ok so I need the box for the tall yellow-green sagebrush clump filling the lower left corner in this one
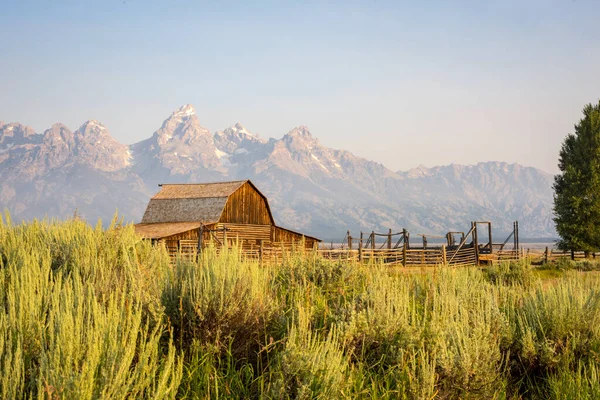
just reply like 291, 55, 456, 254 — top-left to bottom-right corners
0, 212, 182, 399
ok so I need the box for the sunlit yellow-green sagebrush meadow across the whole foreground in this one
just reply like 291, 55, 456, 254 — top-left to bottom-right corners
0, 215, 600, 399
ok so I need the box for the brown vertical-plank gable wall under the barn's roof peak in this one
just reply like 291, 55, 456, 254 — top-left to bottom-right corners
219, 182, 274, 225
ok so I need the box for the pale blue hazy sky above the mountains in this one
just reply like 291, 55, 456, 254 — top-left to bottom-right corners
0, 0, 600, 173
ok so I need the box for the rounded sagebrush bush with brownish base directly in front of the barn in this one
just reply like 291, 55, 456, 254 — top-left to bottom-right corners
162, 245, 279, 358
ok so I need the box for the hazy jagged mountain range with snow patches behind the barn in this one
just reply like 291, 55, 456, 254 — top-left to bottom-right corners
0, 105, 555, 241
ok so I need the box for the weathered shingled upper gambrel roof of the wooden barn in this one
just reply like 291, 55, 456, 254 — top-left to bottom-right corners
142, 180, 273, 224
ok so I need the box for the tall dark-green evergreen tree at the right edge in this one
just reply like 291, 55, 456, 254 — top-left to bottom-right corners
554, 101, 600, 252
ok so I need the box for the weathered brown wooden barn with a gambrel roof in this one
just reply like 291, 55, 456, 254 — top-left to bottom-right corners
135, 180, 320, 254
